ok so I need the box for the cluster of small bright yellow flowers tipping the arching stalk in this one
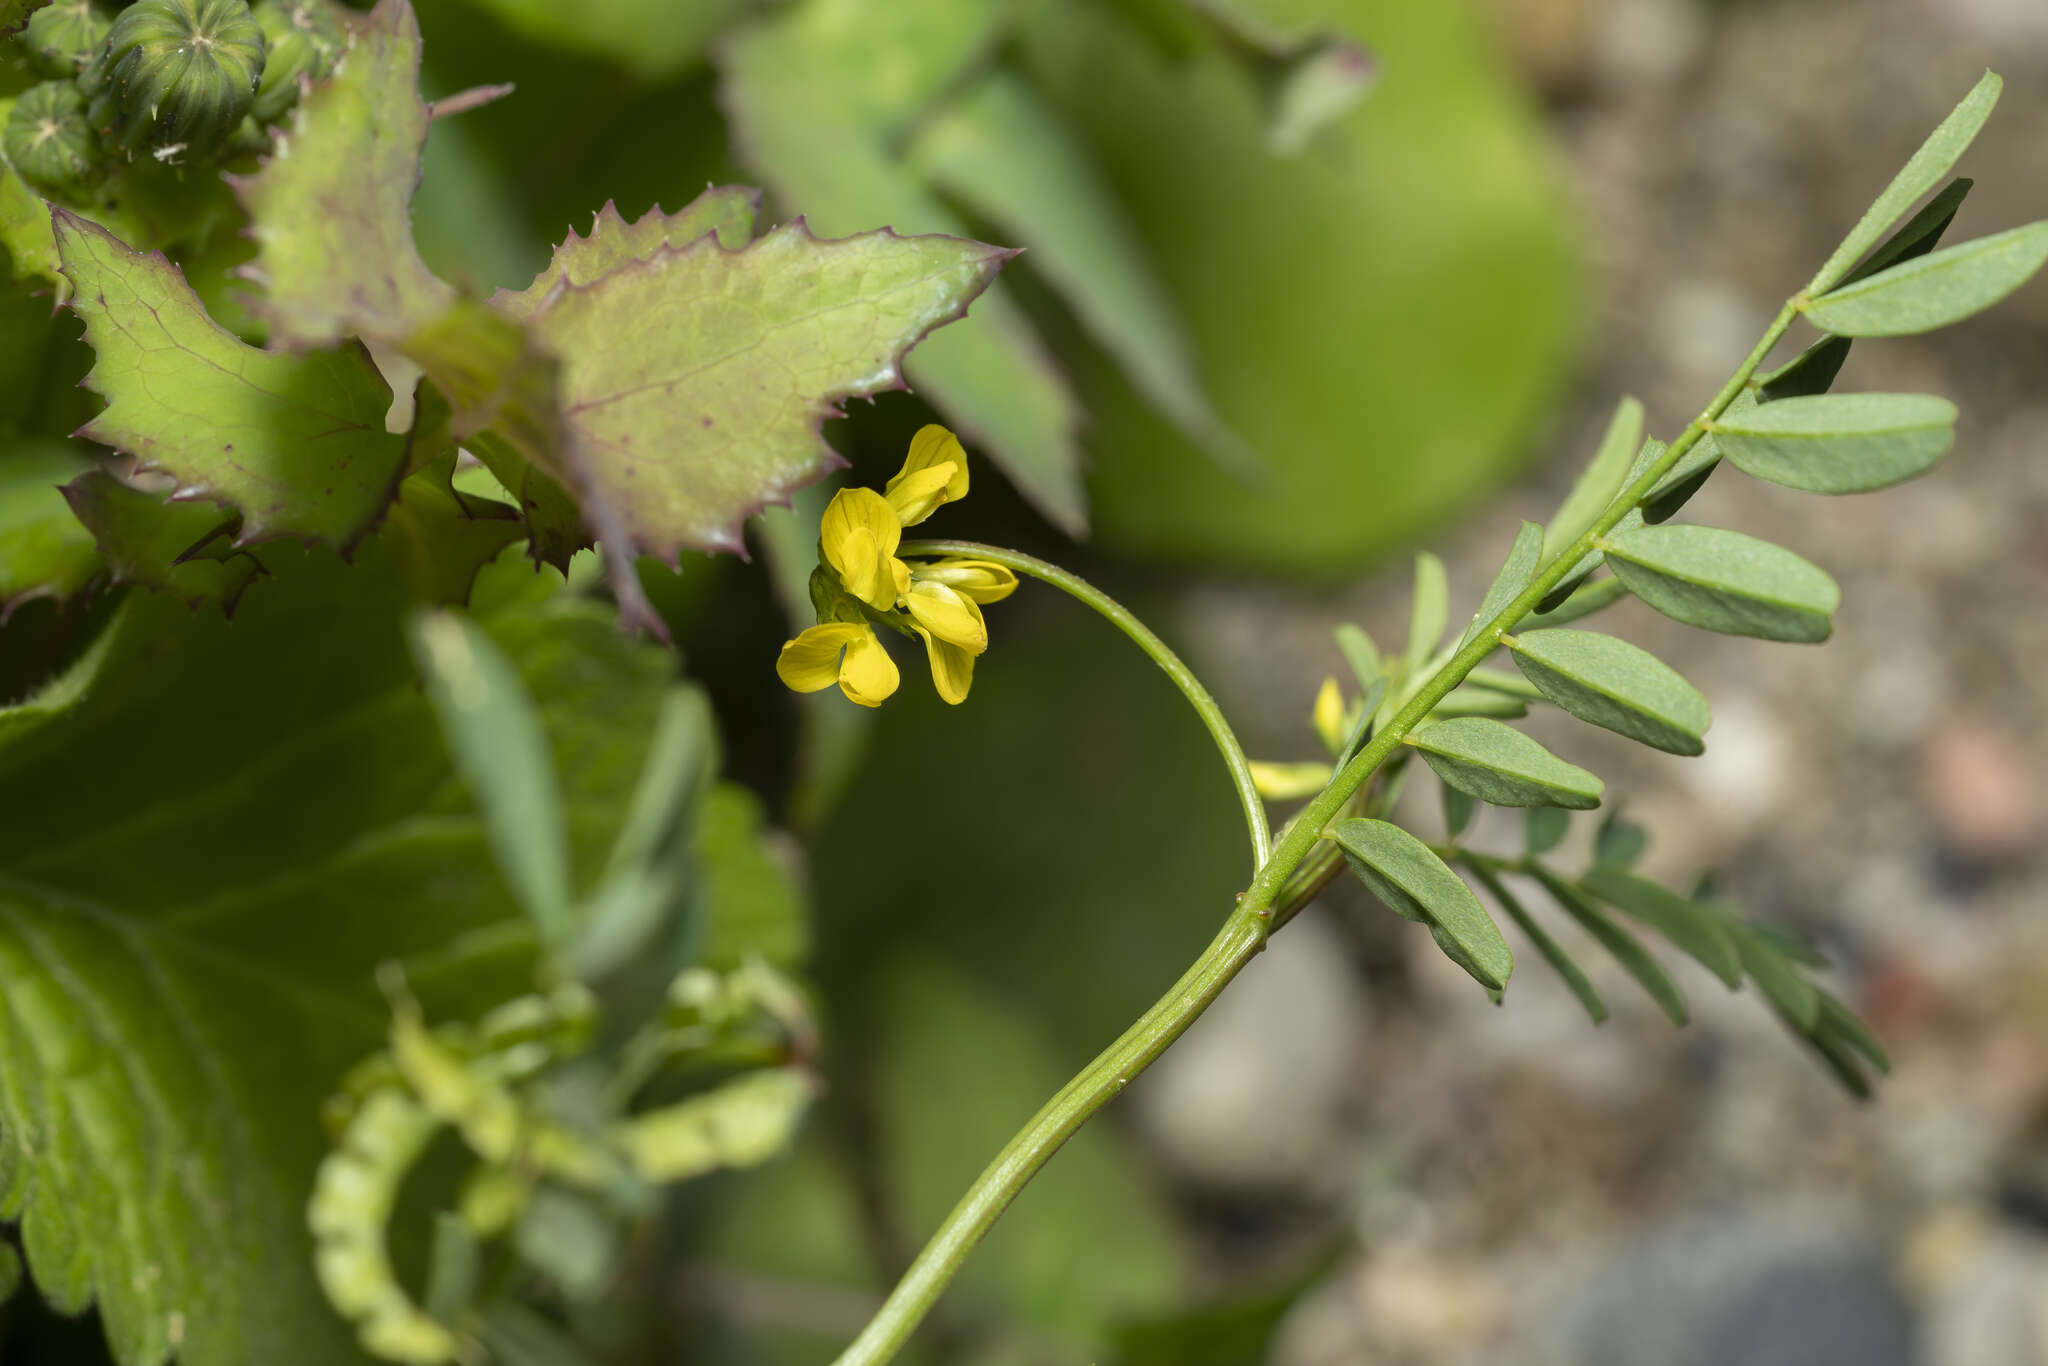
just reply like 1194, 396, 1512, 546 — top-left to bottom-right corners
774, 424, 1018, 707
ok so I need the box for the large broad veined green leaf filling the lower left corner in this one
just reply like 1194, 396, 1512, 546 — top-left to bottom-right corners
0, 543, 672, 1366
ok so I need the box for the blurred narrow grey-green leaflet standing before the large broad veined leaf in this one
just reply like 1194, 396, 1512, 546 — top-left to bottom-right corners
410, 612, 569, 948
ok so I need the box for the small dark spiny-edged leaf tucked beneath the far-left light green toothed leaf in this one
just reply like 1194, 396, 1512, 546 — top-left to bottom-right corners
63, 469, 264, 616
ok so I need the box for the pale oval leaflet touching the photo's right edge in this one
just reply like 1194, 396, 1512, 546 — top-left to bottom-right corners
1806, 221, 2048, 336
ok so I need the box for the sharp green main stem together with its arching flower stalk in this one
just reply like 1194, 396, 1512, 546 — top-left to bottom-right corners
834, 295, 1802, 1366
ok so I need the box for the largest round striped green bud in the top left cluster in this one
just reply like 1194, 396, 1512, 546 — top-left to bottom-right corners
80, 0, 264, 162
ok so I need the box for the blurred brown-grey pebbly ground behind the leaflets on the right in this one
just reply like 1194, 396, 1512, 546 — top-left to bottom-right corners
1137, 0, 2048, 1366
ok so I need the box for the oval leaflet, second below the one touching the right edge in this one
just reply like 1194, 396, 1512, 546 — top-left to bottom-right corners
1602, 526, 1841, 641
